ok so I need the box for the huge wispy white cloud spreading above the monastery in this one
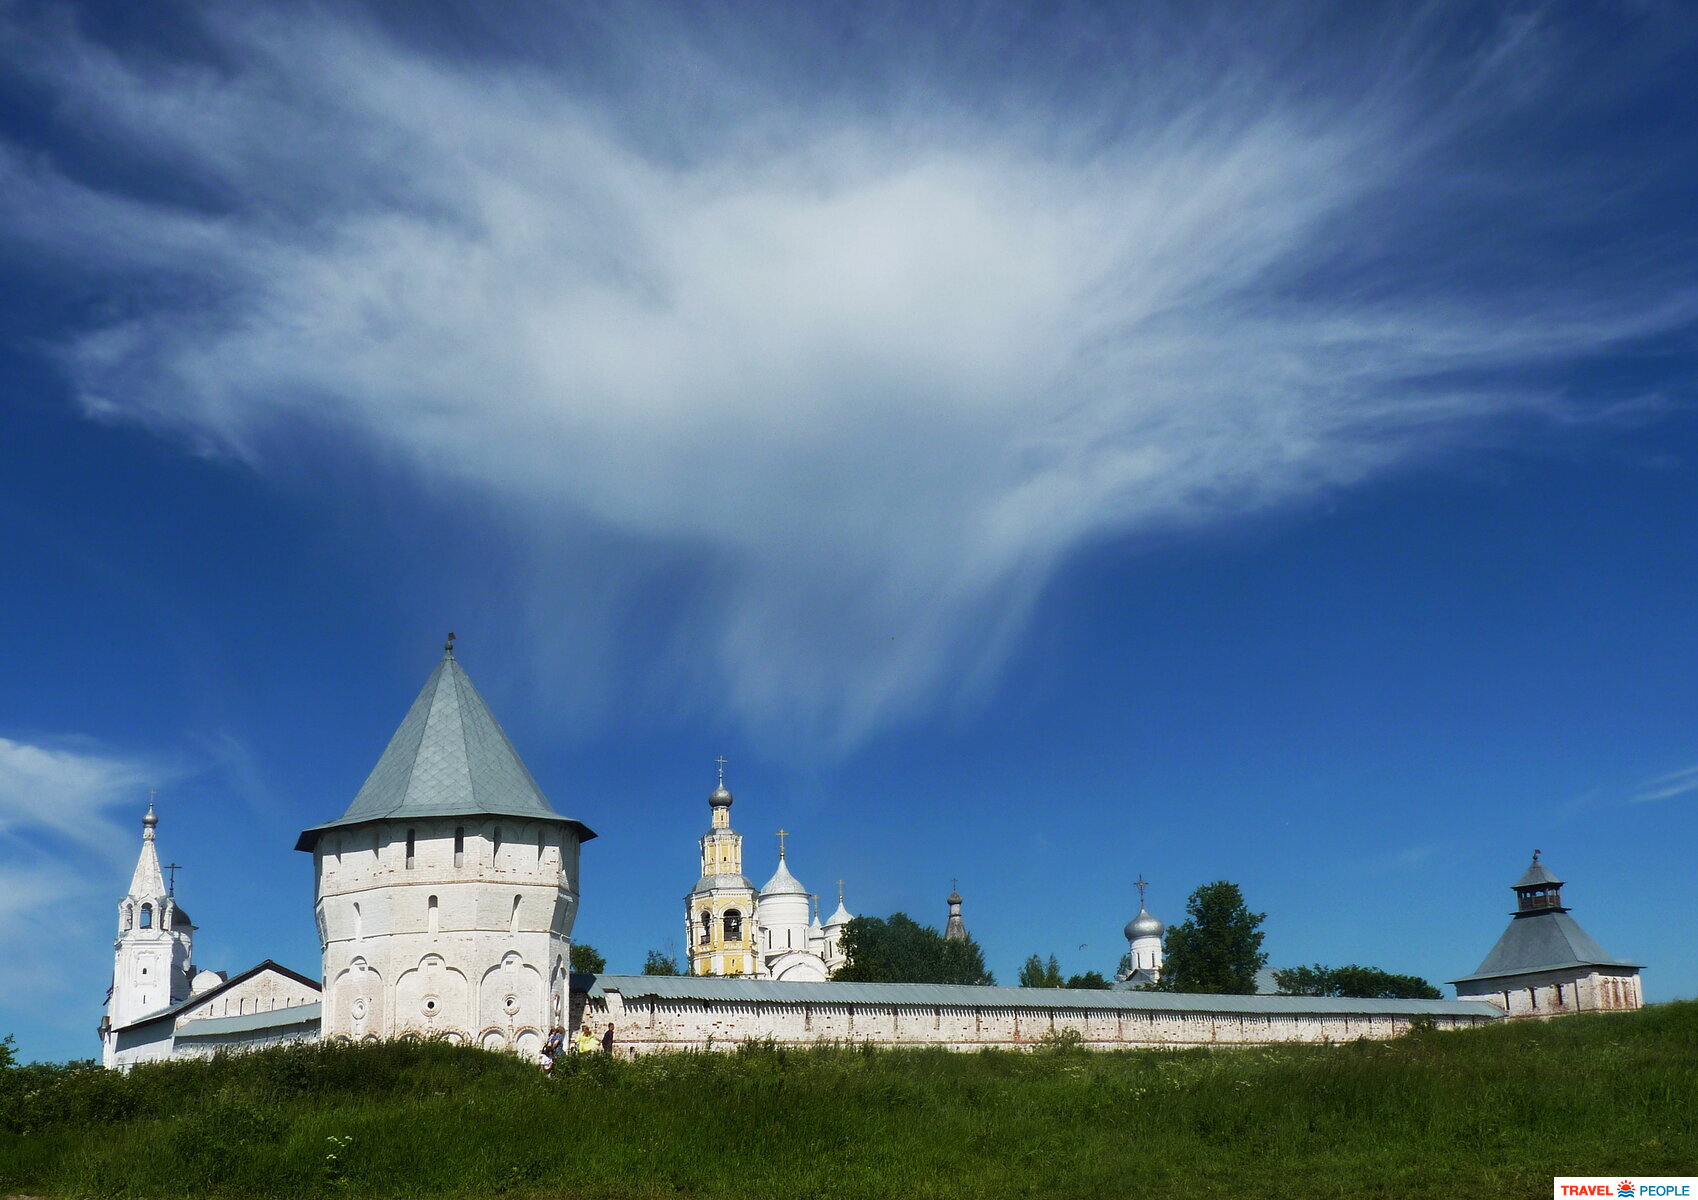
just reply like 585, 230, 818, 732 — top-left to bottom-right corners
0, 4, 1698, 745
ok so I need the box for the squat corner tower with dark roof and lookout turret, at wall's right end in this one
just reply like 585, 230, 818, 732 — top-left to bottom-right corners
1450, 850, 1645, 1017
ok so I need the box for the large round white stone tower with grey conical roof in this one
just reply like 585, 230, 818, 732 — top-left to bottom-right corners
295, 635, 594, 1052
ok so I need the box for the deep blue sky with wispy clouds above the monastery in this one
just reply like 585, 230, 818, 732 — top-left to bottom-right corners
0, 3, 1698, 1057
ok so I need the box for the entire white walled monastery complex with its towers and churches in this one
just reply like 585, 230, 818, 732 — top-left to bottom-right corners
100, 638, 1642, 1068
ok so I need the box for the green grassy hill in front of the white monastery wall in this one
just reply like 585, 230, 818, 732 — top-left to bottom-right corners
0, 1003, 1698, 1200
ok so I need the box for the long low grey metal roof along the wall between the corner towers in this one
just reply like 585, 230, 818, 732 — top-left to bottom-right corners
572, 974, 1503, 1018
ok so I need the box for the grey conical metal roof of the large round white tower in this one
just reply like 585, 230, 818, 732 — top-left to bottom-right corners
295, 650, 594, 850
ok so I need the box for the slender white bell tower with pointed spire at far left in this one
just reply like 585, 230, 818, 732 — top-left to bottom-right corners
100, 799, 195, 1066
